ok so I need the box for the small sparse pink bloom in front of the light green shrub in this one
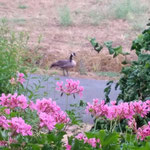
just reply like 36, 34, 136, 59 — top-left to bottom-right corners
10, 72, 25, 85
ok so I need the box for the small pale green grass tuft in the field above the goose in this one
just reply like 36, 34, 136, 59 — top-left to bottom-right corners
58, 6, 72, 26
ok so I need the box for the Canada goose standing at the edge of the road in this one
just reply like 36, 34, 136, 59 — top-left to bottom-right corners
50, 53, 76, 76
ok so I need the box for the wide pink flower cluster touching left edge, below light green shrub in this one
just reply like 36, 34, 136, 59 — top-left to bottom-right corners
0, 93, 28, 109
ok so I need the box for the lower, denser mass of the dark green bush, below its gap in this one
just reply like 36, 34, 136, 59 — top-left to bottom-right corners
117, 54, 150, 101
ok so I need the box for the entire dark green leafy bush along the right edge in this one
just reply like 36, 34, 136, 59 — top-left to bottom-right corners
104, 19, 150, 102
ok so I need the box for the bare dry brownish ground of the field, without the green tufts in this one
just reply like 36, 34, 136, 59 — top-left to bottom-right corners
0, 0, 147, 78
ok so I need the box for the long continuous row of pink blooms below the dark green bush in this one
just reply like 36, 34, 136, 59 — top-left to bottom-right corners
86, 99, 150, 120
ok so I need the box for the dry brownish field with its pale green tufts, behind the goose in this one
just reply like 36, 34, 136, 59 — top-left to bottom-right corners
0, 0, 150, 78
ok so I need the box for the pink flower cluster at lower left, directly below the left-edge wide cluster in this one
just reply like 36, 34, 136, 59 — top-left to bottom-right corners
8, 117, 32, 136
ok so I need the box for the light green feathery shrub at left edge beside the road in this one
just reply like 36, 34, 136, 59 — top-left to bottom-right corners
0, 19, 42, 95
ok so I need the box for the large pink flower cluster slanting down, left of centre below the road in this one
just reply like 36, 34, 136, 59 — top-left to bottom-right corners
30, 98, 69, 130
